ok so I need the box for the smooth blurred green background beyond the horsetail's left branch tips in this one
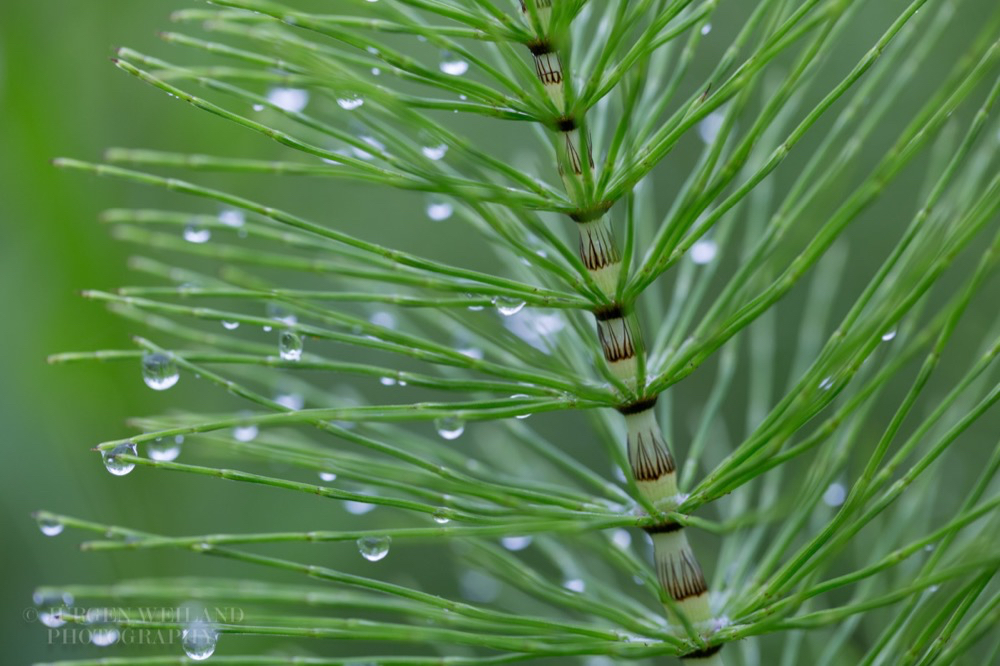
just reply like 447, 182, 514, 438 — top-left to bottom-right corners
0, 0, 992, 664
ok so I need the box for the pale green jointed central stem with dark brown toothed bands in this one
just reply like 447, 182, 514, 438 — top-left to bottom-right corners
521, 0, 723, 666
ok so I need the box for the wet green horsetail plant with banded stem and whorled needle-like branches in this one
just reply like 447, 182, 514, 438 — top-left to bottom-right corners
36, 0, 1000, 665
